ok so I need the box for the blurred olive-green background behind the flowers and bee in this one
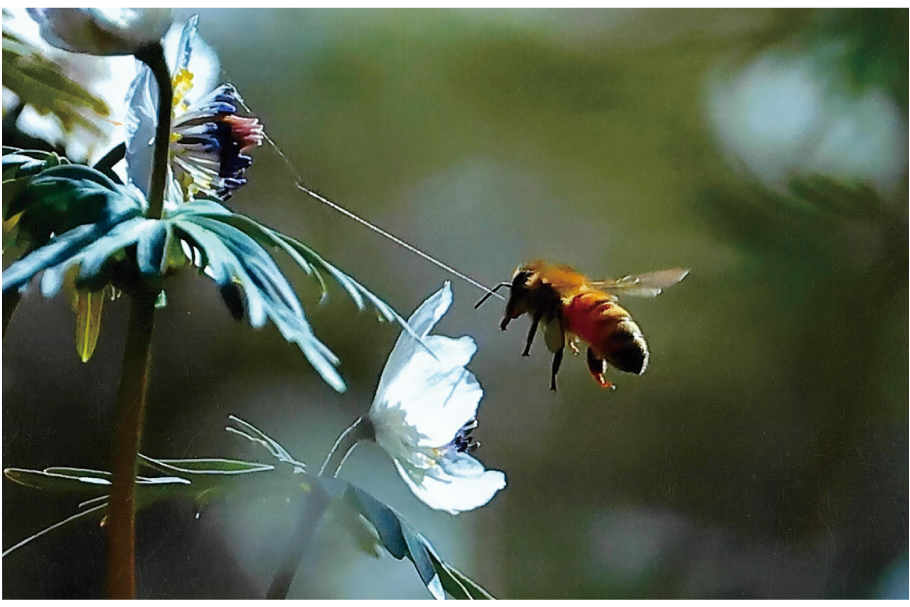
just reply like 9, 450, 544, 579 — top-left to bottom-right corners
3, 9, 908, 599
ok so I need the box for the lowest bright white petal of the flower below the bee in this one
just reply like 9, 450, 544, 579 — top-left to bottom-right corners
395, 461, 506, 514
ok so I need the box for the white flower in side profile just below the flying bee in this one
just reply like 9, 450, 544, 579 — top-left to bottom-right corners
369, 282, 506, 514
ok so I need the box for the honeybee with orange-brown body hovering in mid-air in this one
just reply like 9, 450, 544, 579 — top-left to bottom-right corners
474, 261, 689, 390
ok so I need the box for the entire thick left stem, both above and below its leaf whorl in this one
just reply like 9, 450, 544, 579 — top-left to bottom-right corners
105, 44, 174, 599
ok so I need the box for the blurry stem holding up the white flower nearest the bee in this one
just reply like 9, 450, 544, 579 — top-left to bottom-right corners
265, 417, 373, 599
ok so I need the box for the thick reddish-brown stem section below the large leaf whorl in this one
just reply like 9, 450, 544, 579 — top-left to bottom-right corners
106, 295, 155, 599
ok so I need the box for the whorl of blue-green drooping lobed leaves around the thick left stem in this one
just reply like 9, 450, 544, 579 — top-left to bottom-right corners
3, 184, 420, 392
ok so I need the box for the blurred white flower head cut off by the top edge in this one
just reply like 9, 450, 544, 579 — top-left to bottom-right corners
29, 8, 171, 55
